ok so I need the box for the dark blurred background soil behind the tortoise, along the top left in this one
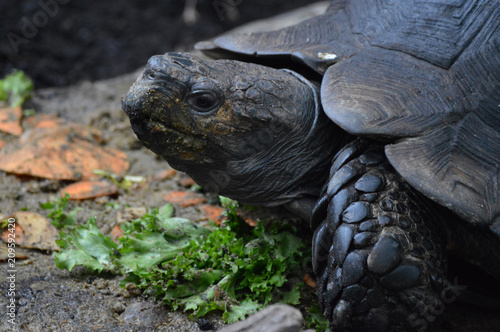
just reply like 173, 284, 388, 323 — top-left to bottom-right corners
0, 0, 320, 88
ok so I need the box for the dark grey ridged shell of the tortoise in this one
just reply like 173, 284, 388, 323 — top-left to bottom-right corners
201, 0, 500, 231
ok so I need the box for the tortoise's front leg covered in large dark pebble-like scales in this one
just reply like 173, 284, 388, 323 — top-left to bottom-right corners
313, 141, 446, 331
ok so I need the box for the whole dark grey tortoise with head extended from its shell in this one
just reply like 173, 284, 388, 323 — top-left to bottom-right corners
123, 0, 500, 331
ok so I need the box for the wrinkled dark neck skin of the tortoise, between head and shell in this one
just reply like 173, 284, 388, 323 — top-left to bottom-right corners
223, 77, 352, 208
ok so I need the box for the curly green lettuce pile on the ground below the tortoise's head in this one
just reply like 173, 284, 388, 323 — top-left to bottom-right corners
55, 201, 310, 322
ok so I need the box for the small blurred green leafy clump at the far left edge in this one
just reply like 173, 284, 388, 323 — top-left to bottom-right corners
0, 70, 33, 107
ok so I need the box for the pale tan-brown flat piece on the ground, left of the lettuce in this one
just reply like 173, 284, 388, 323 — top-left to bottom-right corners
1, 211, 59, 250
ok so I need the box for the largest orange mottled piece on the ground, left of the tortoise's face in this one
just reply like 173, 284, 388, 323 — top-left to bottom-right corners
0, 123, 129, 181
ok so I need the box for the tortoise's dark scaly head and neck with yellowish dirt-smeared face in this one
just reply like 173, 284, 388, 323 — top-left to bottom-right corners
123, 53, 335, 205
